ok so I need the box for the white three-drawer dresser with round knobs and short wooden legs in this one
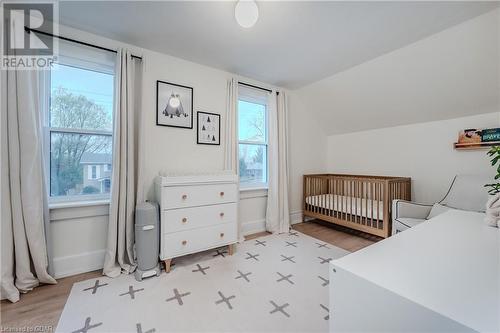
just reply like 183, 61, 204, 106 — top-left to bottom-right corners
155, 174, 239, 273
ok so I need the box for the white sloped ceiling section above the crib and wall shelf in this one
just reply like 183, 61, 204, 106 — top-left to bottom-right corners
295, 9, 500, 134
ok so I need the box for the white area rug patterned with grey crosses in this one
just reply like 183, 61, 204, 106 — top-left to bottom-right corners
57, 232, 349, 333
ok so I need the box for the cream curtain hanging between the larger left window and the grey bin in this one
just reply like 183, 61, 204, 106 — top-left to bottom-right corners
103, 49, 142, 277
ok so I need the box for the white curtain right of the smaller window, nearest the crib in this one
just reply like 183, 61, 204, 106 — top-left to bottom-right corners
266, 92, 290, 233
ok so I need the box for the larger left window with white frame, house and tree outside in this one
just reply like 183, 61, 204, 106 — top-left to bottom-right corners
42, 42, 116, 202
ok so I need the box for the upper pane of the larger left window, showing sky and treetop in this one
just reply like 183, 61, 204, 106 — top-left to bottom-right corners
50, 64, 114, 131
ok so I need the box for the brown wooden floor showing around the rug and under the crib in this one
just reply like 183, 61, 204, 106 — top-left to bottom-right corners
0, 221, 380, 332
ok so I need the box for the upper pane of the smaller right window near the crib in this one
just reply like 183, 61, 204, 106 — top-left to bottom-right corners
238, 100, 266, 143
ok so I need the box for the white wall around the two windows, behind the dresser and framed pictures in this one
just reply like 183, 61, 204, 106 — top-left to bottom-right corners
51, 26, 326, 277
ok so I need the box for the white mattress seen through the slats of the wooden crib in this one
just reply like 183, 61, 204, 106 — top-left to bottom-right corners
306, 194, 384, 220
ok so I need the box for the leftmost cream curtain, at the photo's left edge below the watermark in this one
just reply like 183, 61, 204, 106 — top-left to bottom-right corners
0, 70, 56, 302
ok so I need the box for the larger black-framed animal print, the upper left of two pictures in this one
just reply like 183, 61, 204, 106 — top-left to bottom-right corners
156, 80, 193, 128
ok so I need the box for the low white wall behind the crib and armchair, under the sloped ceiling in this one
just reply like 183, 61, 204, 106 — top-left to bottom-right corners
328, 112, 500, 203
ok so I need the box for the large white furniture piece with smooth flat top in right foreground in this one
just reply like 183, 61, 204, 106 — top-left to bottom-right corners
330, 210, 500, 332
